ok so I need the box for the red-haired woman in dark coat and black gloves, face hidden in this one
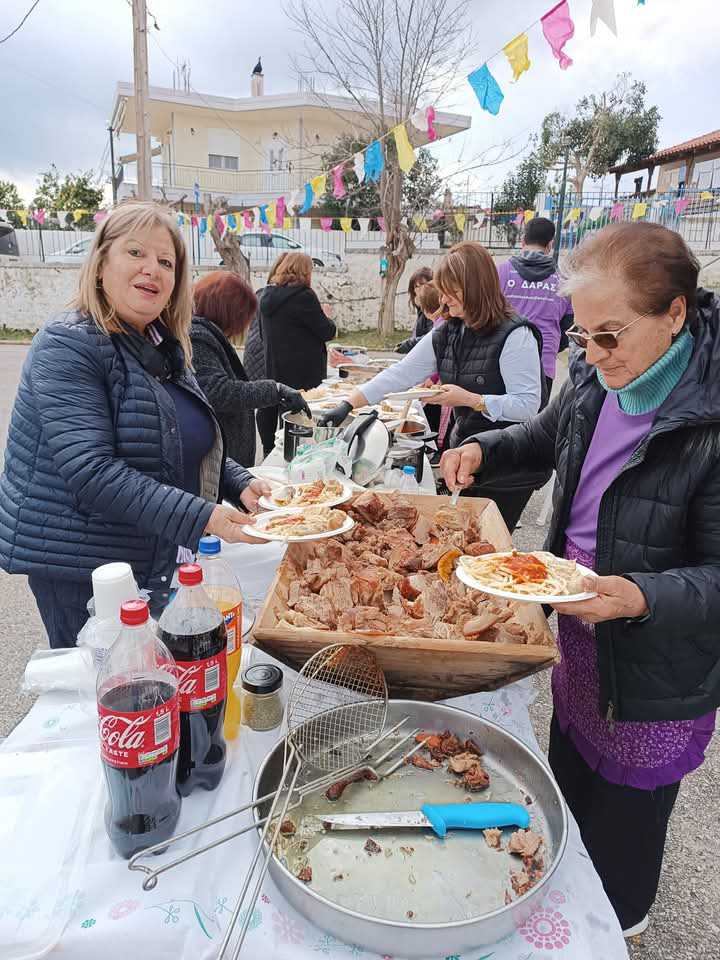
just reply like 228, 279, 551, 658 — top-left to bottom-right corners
190, 270, 310, 466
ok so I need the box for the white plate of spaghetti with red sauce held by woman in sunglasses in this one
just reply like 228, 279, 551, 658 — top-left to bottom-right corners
455, 550, 597, 603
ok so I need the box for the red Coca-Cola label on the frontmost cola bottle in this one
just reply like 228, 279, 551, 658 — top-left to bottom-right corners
98, 696, 180, 770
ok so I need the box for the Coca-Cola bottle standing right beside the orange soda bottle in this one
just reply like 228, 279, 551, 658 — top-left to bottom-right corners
158, 563, 227, 797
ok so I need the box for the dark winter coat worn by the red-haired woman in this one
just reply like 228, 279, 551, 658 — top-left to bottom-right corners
190, 317, 279, 467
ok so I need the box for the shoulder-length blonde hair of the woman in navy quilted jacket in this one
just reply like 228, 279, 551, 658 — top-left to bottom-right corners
70, 200, 192, 366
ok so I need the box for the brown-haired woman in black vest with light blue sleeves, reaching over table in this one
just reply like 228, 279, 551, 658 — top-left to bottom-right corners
322, 241, 550, 530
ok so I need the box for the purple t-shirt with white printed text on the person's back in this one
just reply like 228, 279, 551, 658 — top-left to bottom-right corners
498, 260, 572, 378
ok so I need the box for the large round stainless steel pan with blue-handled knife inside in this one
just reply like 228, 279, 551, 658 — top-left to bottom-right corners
253, 700, 567, 958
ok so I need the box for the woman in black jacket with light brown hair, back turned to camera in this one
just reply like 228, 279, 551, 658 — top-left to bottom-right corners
258, 253, 336, 454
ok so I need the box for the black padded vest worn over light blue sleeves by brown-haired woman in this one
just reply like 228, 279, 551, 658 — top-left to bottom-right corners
432, 317, 548, 447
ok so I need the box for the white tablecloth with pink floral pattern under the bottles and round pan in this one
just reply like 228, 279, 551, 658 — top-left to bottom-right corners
0, 543, 627, 960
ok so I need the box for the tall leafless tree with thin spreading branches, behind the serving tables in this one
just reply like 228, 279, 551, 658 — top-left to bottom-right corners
287, 0, 472, 333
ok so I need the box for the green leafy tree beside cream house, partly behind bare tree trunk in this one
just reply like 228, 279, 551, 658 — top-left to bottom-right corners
319, 140, 442, 217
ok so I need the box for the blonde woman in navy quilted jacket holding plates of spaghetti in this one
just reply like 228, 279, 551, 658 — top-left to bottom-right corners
0, 203, 267, 647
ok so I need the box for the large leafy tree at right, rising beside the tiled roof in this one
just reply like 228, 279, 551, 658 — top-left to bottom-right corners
540, 73, 660, 195
